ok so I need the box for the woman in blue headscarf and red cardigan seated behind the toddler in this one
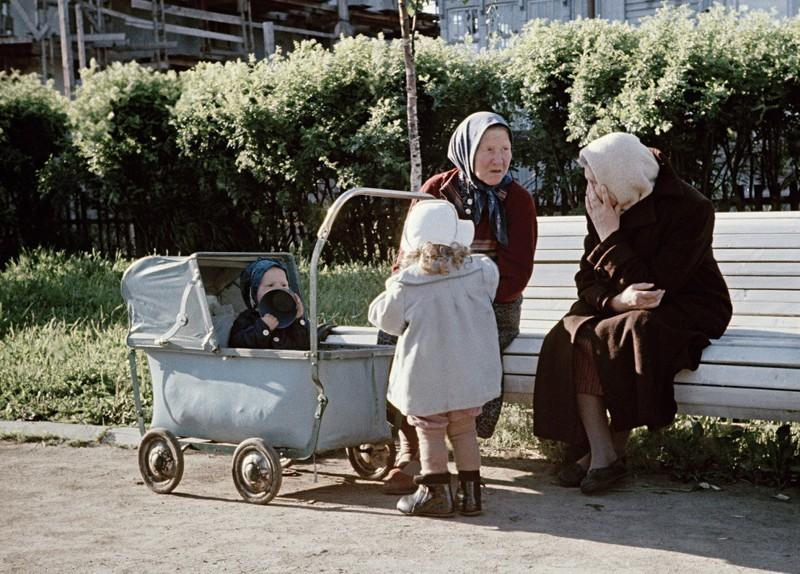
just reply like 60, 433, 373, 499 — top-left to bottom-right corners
384, 112, 536, 494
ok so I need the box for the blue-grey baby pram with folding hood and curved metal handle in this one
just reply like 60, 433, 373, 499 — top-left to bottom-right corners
122, 188, 430, 504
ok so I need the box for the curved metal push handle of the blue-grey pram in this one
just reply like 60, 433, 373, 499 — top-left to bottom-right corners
308, 187, 433, 392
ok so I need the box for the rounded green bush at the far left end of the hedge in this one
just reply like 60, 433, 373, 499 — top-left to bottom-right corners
0, 71, 69, 264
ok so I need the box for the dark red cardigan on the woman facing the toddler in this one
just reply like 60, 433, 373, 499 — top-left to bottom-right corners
393, 169, 537, 303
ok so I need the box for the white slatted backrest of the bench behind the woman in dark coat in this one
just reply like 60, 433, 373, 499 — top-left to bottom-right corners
521, 211, 800, 336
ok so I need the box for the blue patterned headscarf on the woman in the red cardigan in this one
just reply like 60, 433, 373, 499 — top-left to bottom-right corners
447, 112, 513, 245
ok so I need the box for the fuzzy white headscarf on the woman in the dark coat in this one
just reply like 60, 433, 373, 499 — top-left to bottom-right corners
578, 132, 659, 210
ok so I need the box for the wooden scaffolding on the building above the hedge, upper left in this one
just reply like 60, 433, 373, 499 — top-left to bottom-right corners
0, 0, 438, 94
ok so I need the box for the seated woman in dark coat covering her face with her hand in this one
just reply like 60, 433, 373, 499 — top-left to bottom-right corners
534, 133, 732, 494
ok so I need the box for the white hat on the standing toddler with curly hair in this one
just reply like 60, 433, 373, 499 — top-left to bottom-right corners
400, 199, 475, 253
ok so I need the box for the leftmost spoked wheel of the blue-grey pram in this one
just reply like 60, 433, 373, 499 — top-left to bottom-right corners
139, 428, 183, 494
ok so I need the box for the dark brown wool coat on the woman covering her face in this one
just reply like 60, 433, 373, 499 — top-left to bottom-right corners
533, 150, 732, 444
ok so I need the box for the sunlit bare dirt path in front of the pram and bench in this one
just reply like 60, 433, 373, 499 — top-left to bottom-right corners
0, 441, 800, 574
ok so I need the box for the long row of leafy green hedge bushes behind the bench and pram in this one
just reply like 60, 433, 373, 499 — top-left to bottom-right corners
0, 5, 800, 263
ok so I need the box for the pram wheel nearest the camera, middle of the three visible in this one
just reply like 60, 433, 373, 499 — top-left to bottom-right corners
231, 438, 283, 504
